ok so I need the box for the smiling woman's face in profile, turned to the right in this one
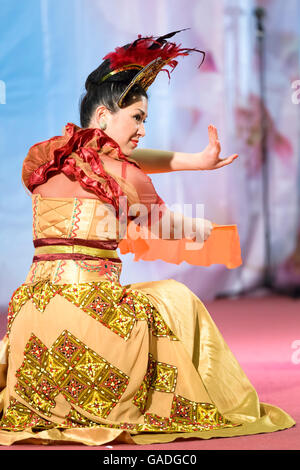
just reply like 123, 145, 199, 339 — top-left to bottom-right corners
95, 96, 148, 157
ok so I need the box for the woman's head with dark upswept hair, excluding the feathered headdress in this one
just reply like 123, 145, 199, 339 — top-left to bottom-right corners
80, 60, 148, 156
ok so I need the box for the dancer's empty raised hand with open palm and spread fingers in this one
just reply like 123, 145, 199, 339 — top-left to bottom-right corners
193, 125, 238, 170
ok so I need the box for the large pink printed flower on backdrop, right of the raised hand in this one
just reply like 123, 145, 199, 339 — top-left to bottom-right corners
235, 94, 293, 176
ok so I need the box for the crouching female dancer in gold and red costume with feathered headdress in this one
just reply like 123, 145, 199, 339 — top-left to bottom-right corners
0, 33, 295, 445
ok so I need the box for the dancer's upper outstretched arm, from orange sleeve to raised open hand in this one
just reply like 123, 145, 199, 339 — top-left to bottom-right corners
131, 125, 238, 173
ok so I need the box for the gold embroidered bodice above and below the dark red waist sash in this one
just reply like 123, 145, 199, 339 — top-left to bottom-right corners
25, 194, 122, 284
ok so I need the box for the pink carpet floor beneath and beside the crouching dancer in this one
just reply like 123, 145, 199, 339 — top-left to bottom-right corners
0, 294, 300, 452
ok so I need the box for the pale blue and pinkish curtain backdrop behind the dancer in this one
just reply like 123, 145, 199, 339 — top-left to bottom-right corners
0, 0, 300, 307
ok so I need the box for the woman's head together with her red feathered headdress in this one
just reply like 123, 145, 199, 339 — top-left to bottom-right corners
80, 30, 205, 155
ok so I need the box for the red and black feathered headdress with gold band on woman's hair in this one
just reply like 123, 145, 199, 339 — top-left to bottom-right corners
100, 30, 205, 108
